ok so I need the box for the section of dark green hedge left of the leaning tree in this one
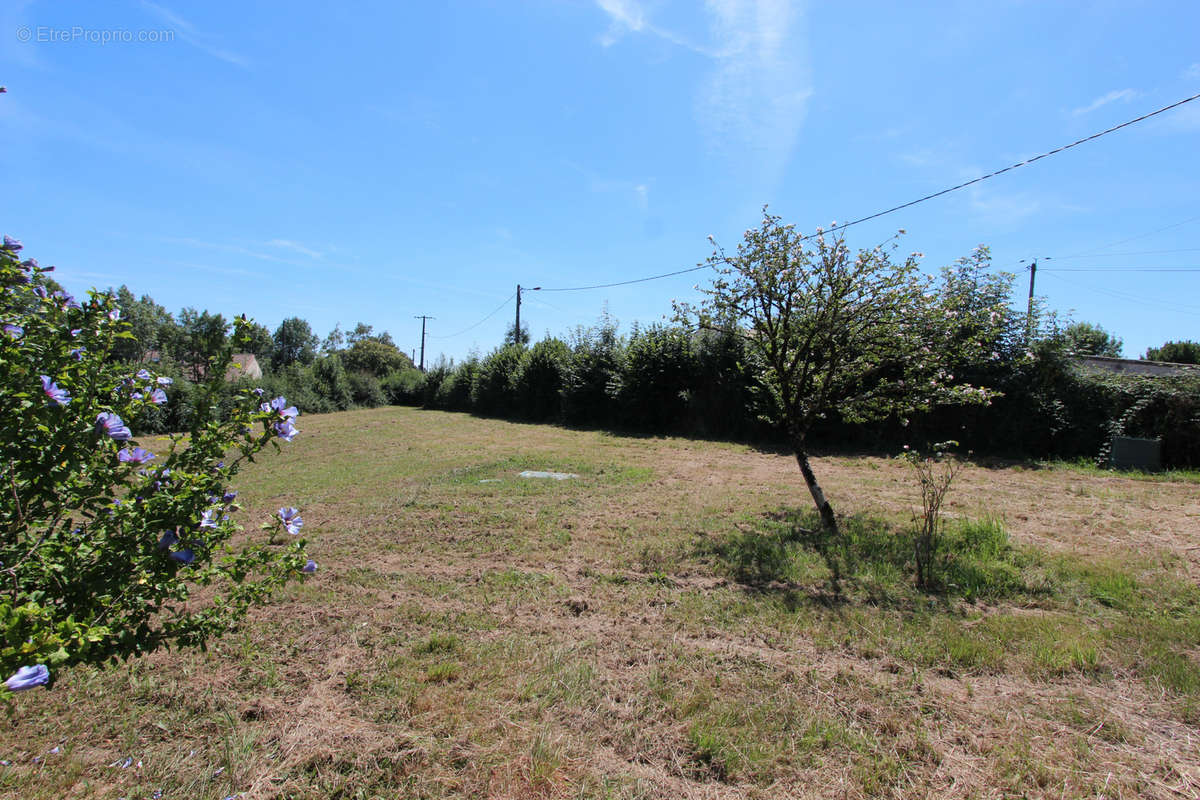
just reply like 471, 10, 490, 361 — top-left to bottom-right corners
389, 320, 764, 438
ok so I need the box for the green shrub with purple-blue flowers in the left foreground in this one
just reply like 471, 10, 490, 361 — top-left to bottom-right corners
0, 236, 316, 692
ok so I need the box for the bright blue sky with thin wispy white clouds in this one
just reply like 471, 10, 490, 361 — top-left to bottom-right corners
0, 0, 1200, 359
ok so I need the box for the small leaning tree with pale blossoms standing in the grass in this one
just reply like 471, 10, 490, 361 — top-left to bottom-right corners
677, 209, 998, 531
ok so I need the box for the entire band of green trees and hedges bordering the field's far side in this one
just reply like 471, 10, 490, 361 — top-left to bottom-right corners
105, 255, 1200, 467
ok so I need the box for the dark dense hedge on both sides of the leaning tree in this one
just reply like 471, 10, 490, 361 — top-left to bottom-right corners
384, 320, 1200, 467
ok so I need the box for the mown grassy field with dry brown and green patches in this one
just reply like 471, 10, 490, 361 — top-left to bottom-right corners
0, 408, 1200, 800
